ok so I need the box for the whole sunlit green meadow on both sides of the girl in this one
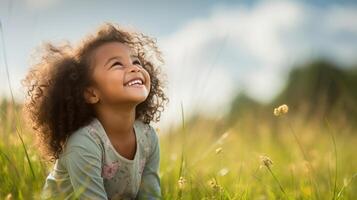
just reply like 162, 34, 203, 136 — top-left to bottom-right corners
0, 100, 357, 200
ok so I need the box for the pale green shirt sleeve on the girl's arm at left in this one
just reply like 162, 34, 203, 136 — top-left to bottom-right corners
64, 131, 108, 200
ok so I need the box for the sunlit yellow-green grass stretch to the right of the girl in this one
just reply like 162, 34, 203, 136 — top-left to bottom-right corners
161, 112, 357, 199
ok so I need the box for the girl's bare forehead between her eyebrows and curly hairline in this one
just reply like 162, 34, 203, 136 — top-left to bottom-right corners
92, 42, 135, 65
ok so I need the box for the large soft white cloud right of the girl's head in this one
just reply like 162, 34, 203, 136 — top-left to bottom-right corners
160, 1, 357, 129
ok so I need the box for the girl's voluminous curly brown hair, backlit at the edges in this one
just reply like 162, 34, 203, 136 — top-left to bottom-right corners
22, 23, 169, 162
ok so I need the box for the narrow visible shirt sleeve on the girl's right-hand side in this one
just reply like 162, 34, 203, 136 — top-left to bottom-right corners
136, 126, 162, 200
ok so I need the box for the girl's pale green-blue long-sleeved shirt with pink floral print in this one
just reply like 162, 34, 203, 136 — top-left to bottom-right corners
41, 118, 162, 200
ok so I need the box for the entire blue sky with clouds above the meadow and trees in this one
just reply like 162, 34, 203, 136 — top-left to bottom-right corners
0, 0, 357, 127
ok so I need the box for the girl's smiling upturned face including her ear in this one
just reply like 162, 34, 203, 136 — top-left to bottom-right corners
85, 42, 150, 108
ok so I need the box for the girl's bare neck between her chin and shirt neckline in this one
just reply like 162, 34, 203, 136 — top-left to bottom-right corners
96, 105, 135, 139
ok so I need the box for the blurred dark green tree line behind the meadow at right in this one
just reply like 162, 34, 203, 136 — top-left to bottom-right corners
227, 59, 357, 130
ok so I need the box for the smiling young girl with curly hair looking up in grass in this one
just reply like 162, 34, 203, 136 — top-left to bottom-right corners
23, 23, 168, 199
